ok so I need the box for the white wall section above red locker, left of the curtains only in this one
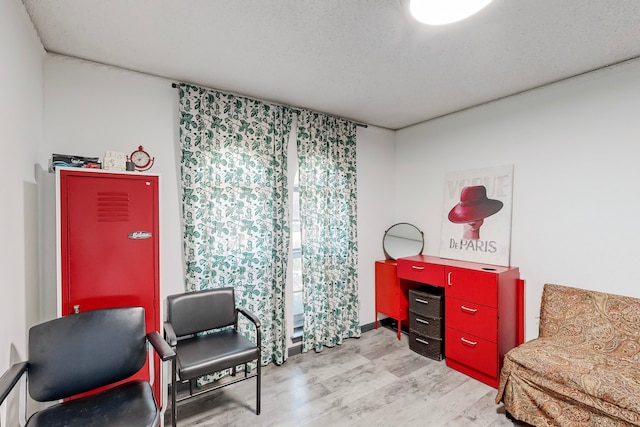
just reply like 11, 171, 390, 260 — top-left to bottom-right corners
38, 55, 184, 324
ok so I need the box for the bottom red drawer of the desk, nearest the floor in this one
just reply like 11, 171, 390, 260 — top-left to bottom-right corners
445, 327, 498, 377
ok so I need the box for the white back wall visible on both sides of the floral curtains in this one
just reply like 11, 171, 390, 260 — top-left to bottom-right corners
39, 55, 394, 342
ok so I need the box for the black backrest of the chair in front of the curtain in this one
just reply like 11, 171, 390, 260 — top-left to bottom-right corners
167, 287, 236, 337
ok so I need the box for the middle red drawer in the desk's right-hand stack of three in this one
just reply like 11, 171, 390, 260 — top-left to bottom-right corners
445, 297, 498, 343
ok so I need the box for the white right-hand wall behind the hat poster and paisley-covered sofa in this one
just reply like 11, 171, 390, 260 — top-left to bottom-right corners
395, 57, 640, 339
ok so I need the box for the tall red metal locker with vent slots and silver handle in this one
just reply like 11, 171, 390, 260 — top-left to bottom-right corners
57, 169, 161, 402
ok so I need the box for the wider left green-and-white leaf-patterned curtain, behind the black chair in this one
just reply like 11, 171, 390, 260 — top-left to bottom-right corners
179, 84, 292, 372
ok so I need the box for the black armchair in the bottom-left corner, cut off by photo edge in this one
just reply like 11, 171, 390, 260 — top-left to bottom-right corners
0, 307, 175, 427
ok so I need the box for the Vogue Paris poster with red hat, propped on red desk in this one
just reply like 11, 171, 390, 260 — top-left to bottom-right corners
440, 165, 513, 266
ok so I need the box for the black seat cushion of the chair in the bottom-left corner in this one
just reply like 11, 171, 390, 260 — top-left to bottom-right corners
27, 380, 160, 427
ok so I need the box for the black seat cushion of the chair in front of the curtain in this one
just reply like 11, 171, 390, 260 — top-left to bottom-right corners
177, 330, 260, 378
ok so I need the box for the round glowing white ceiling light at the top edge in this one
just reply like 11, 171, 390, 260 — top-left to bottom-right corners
409, 0, 491, 25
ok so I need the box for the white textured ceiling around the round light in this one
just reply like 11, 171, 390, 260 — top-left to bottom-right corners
23, 0, 640, 129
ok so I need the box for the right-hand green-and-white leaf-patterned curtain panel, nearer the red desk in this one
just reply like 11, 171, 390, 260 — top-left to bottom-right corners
298, 111, 360, 352
